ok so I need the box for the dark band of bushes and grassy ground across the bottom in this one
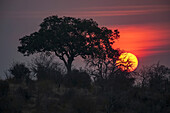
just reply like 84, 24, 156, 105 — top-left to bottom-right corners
0, 56, 170, 113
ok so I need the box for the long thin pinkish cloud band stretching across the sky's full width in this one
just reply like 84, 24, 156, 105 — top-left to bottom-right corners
0, 5, 170, 18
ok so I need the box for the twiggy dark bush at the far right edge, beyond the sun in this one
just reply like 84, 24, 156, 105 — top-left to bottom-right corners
137, 63, 170, 91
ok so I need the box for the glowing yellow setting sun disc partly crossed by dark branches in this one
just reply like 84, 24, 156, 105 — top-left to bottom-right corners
116, 52, 138, 72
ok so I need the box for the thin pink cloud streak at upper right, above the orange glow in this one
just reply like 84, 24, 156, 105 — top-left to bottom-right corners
65, 5, 170, 17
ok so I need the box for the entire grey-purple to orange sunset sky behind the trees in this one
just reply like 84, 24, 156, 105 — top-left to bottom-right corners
0, 0, 170, 76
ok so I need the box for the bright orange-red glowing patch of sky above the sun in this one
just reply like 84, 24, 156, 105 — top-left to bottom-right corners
110, 24, 170, 58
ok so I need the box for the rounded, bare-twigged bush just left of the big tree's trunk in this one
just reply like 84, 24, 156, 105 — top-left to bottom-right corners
31, 53, 63, 87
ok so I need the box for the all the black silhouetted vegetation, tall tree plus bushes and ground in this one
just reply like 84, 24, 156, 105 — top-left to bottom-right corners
0, 16, 170, 113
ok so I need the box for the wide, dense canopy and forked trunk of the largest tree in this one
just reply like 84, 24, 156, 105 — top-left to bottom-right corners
18, 16, 119, 72
